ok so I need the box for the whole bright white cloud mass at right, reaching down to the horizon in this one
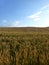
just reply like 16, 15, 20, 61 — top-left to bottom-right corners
27, 4, 49, 27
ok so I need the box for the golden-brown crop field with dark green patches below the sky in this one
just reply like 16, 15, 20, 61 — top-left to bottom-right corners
0, 27, 49, 65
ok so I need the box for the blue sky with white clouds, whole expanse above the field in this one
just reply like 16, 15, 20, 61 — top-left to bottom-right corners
0, 0, 49, 27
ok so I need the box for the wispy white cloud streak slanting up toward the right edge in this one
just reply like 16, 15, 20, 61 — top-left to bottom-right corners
27, 4, 49, 21
